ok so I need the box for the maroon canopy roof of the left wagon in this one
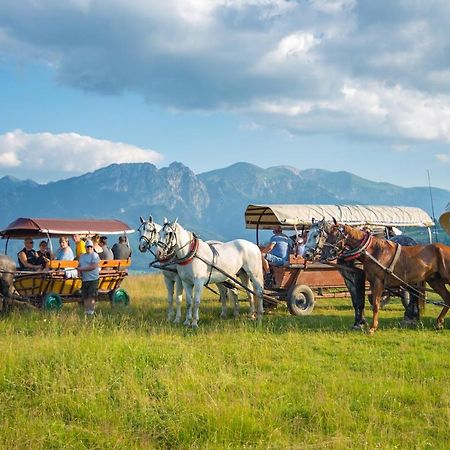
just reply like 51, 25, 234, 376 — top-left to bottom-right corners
0, 217, 134, 238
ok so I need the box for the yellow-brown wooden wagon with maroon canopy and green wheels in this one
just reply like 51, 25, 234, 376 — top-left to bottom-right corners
0, 218, 134, 309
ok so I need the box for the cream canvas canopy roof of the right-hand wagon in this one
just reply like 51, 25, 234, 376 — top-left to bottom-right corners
245, 205, 434, 229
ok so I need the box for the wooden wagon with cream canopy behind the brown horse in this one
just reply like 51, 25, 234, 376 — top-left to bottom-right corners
245, 205, 434, 316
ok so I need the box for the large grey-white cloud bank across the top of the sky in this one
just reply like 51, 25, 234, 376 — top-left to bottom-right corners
0, 0, 450, 147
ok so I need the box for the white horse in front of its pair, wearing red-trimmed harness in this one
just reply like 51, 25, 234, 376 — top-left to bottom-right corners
158, 221, 264, 327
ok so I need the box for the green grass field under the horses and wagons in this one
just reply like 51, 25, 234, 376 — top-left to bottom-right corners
0, 276, 450, 449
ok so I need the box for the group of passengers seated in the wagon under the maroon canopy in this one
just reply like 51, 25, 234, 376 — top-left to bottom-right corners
17, 234, 131, 270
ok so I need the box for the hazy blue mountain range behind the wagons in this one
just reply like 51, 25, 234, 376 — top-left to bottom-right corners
0, 162, 450, 267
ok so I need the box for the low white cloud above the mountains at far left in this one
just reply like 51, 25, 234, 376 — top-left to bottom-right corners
0, 130, 163, 181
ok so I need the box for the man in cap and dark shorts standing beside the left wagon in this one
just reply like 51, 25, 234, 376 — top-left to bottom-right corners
78, 239, 100, 316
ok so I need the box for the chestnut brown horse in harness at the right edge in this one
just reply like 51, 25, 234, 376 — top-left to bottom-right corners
322, 222, 450, 333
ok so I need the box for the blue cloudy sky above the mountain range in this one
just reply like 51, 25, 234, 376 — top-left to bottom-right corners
0, 0, 450, 190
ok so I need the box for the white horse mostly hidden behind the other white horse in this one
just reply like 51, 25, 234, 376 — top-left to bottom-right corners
139, 216, 239, 323
